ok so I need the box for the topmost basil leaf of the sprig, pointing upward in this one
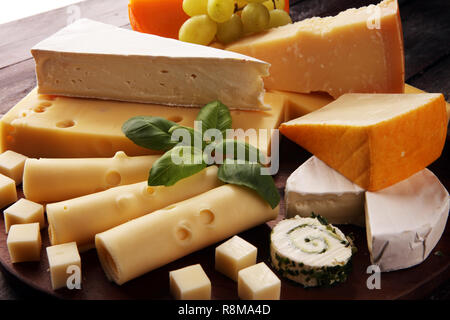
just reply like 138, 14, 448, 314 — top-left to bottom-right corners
196, 101, 232, 137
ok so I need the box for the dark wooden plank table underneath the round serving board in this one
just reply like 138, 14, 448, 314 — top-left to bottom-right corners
0, 0, 450, 299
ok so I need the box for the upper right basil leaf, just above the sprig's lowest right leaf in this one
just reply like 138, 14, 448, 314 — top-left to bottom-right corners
215, 139, 266, 163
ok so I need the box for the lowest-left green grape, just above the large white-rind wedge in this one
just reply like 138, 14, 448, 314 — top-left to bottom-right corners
178, 14, 217, 45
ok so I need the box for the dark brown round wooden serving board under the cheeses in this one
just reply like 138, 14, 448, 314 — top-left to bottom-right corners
0, 136, 450, 300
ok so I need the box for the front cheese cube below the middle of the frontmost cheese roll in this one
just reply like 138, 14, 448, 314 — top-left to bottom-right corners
169, 264, 211, 300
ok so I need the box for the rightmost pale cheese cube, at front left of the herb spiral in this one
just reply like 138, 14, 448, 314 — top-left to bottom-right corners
238, 262, 281, 300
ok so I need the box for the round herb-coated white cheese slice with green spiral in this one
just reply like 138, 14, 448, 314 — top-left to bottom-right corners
270, 216, 352, 287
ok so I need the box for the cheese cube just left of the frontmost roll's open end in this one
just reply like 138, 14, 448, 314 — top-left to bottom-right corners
47, 242, 81, 290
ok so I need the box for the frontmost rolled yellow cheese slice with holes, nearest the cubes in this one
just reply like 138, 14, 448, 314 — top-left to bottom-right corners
95, 185, 279, 285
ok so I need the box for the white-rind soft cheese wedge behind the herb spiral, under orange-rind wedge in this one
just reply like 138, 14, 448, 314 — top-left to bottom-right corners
285, 156, 364, 226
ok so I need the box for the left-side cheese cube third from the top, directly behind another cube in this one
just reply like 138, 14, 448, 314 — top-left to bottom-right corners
3, 198, 45, 233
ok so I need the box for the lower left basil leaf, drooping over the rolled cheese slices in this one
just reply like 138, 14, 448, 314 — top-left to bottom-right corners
148, 146, 206, 186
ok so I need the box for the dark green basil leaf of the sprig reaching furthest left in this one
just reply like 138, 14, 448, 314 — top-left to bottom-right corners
122, 116, 178, 151
